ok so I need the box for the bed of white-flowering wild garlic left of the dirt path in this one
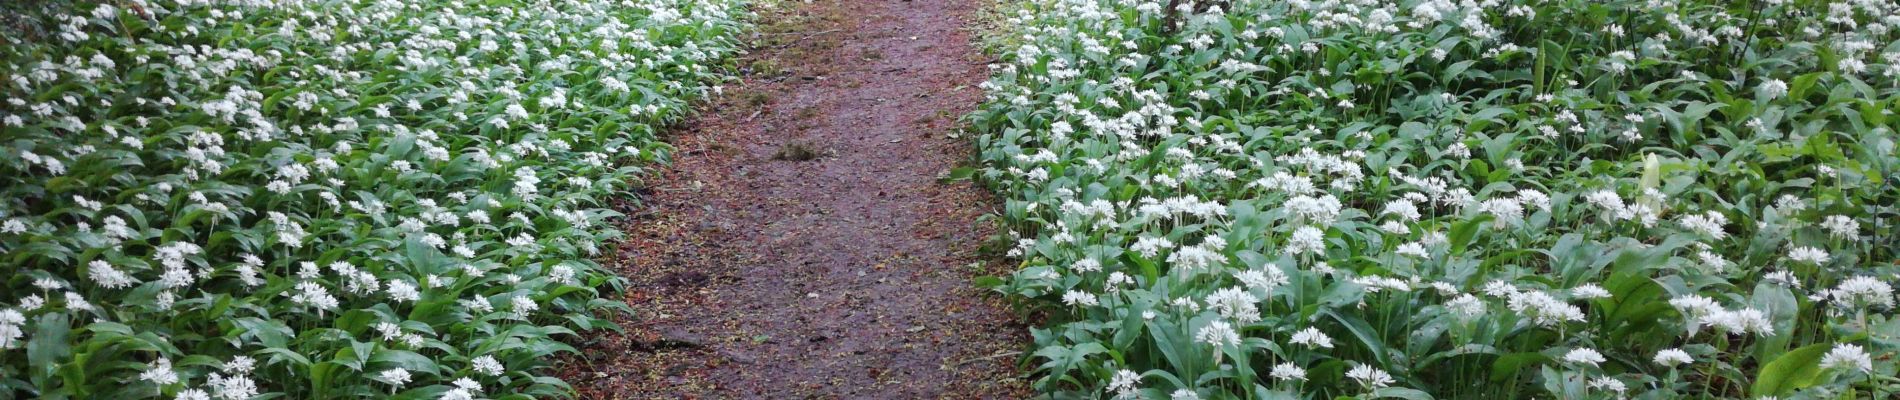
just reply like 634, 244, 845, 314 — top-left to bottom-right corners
0, 0, 745, 400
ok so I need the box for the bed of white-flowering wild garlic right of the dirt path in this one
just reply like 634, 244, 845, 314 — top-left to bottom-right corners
969, 0, 1900, 400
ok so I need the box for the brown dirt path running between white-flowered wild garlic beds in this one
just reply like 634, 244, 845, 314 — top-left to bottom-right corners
564, 0, 1028, 398
